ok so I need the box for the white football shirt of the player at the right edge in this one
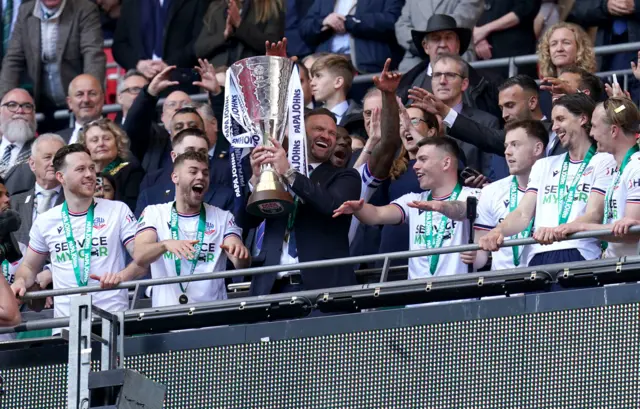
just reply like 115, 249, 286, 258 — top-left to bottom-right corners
605, 152, 640, 257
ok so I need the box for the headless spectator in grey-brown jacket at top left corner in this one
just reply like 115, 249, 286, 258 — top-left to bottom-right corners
0, 0, 106, 129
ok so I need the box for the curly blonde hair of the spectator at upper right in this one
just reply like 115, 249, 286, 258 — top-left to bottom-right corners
538, 22, 597, 77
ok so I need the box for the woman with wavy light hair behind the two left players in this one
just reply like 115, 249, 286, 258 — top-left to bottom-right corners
78, 118, 144, 211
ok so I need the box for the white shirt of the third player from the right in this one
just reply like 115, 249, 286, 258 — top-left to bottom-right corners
474, 176, 531, 270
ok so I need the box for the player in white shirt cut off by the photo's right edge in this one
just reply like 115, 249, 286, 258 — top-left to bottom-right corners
557, 98, 640, 257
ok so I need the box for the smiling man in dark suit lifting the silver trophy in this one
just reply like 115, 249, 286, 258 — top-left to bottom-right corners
236, 108, 361, 295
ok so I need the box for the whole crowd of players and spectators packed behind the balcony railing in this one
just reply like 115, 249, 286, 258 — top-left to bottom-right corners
0, 0, 640, 332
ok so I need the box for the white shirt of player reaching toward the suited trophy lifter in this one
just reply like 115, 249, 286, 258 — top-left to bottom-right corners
391, 187, 480, 280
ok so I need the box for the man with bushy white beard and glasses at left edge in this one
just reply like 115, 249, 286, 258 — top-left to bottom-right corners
0, 88, 36, 179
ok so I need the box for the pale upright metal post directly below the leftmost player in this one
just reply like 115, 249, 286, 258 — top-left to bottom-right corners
67, 294, 91, 409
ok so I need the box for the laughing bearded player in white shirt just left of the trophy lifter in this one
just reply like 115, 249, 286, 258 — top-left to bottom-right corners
135, 151, 251, 307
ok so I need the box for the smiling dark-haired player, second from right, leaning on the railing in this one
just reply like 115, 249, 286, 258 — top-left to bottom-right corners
479, 94, 615, 266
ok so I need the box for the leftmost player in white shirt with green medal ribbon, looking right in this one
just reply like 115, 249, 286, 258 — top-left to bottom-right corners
11, 144, 145, 324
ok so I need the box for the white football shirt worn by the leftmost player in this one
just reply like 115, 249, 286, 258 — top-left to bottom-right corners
29, 199, 137, 324
